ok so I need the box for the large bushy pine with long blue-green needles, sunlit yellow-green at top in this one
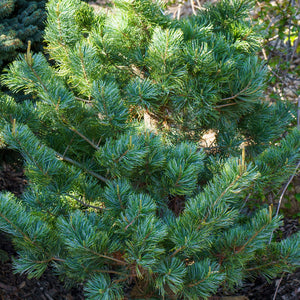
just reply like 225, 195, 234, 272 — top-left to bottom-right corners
0, 0, 300, 299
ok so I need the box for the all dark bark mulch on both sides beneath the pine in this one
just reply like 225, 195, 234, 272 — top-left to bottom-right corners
0, 150, 300, 300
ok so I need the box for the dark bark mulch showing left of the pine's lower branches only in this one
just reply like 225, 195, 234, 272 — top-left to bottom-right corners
0, 149, 84, 300
